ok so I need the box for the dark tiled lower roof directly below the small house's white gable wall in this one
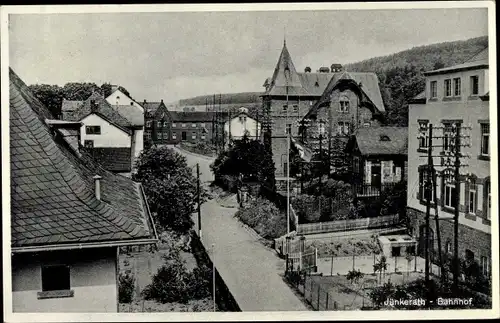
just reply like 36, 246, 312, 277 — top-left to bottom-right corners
80, 147, 132, 173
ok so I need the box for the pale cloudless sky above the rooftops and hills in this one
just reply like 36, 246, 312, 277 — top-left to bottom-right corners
9, 8, 488, 102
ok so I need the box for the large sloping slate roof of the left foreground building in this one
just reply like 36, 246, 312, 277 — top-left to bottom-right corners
10, 70, 157, 251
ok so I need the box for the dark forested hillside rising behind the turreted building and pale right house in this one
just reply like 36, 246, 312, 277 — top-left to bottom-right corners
344, 36, 488, 126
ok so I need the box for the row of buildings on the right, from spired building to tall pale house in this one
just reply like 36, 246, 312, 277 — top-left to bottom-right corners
268, 42, 492, 274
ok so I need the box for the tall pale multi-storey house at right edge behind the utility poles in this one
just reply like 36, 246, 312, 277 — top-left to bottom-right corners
408, 48, 492, 275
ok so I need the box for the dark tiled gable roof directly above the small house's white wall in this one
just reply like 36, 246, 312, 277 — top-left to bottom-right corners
63, 92, 132, 134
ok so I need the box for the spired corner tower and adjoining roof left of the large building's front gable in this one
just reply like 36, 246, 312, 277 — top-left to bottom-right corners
262, 41, 333, 177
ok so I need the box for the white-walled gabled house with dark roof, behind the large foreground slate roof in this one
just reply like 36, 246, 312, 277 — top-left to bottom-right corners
62, 92, 144, 174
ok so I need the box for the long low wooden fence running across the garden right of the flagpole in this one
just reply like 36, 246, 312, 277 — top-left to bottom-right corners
297, 214, 400, 234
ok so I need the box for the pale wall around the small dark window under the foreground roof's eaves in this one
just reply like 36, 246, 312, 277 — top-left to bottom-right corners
12, 248, 118, 313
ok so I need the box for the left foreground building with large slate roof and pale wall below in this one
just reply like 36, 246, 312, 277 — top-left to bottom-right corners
9, 70, 157, 313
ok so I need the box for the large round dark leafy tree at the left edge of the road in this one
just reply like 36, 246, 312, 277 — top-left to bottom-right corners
132, 147, 206, 234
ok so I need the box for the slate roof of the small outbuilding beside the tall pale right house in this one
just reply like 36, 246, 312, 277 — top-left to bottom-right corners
351, 127, 408, 156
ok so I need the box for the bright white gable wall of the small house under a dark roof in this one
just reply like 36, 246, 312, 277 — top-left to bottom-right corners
80, 114, 131, 148
